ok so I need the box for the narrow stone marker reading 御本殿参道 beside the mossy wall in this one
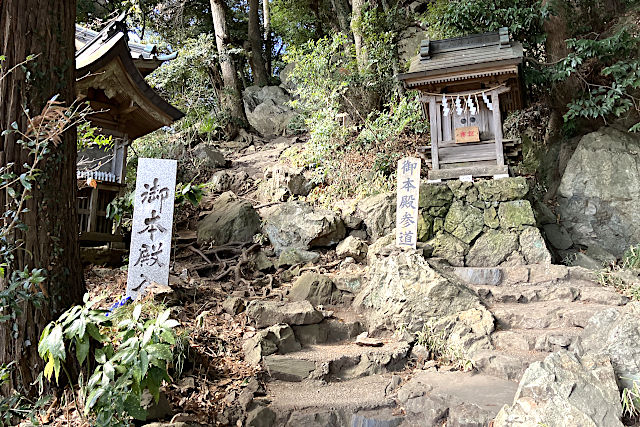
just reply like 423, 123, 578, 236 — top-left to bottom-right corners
396, 157, 420, 249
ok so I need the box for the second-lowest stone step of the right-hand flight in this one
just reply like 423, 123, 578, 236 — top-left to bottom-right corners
491, 327, 582, 352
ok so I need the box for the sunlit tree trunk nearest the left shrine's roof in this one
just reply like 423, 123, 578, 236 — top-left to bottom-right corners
211, 0, 247, 136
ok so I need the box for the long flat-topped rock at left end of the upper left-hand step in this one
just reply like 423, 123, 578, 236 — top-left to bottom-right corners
247, 300, 324, 328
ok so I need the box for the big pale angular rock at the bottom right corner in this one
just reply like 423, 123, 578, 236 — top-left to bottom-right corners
493, 350, 622, 427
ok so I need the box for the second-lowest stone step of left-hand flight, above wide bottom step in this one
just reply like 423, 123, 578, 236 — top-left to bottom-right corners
264, 340, 410, 382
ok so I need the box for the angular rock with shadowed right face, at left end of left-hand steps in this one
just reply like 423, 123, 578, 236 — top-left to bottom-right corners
242, 324, 301, 365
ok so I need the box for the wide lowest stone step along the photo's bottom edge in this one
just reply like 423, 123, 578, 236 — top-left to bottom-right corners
266, 371, 517, 427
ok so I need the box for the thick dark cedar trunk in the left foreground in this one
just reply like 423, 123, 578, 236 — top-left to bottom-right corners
0, 0, 84, 392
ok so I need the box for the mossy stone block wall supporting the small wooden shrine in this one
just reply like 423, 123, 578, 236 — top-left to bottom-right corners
418, 177, 551, 267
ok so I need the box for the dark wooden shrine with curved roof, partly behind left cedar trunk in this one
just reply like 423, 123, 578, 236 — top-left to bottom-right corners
75, 17, 184, 242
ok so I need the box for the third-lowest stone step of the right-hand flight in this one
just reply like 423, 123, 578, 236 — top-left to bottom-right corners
489, 301, 610, 330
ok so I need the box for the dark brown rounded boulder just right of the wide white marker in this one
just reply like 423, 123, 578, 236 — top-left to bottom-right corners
198, 192, 260, 245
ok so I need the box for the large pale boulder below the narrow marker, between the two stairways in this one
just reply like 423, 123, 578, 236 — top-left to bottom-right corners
354, 249, 494, 355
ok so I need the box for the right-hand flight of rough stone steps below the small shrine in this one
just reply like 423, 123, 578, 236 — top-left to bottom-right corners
454, 265, 628, 381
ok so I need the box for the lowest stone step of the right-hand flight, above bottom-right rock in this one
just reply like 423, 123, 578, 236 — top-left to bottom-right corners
472, 350, 549, 382
